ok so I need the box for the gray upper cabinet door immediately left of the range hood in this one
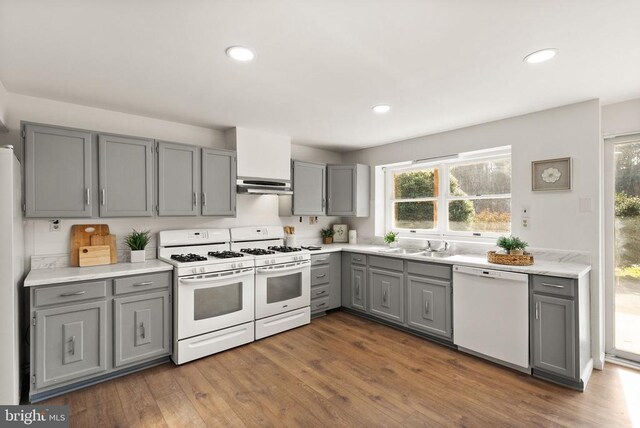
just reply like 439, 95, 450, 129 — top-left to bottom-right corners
202, 149, 236, 216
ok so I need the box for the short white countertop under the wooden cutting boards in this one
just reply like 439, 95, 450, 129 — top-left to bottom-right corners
24, 259, 173, 287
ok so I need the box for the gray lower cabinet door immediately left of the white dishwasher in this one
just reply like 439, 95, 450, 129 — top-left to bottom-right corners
407, 275, 453, 339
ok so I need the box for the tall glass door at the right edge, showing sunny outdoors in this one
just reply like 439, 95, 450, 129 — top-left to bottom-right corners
607, 136, 640, 362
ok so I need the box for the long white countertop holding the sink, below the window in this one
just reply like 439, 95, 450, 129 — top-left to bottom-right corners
311, 243, 591, 278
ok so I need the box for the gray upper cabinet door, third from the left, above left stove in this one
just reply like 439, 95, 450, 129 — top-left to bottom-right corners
158, 142, 200, 216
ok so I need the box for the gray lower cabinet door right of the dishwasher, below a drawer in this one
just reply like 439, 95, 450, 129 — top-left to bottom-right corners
532, 294, 576, 378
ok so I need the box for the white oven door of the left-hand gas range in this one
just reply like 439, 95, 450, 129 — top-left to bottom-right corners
177, 268, 254, 339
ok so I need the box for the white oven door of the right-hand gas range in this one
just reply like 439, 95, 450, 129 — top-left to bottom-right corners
256, 260, 311, 319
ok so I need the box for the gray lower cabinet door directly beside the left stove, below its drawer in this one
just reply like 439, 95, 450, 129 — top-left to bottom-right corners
113, 291, 171, 367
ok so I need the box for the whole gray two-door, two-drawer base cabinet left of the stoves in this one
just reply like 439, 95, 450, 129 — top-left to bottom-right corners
29, 271, 172, 402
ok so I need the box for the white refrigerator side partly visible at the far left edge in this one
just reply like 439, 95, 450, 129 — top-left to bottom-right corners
0, 146, 24, 405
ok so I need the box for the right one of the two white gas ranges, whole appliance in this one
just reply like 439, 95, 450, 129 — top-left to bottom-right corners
231, 226, 311, 339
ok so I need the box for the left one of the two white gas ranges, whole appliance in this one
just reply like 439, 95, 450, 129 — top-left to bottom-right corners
158, 229, 255, 364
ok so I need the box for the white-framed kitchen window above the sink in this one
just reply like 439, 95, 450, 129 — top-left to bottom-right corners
383, 148, 511, 237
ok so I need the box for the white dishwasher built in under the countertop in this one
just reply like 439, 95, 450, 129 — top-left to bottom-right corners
453, 266, 530, 372
